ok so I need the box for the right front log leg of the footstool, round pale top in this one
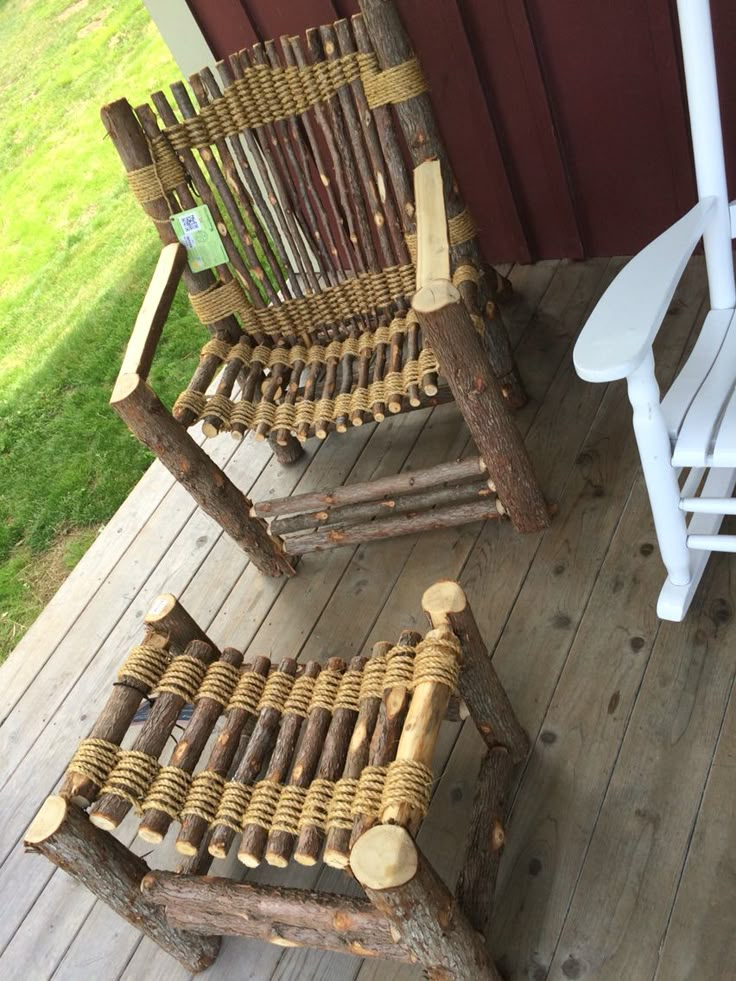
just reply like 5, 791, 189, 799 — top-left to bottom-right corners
350, 825, 501, 981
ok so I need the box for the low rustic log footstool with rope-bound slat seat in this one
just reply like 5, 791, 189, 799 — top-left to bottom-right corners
25, 581, 529, 981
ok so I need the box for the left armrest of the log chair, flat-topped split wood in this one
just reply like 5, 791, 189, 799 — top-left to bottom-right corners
120, 242, 187, 379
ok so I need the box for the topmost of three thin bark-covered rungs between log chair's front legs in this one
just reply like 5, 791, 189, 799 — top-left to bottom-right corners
254, 456, 487, 517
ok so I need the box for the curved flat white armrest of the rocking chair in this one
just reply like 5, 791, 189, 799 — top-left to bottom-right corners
573, 198, 716, 382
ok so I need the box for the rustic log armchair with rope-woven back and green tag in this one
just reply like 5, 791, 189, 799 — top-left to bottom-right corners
102, 0, 548, 575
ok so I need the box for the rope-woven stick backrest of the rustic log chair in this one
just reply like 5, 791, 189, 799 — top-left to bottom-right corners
103, 3, 488, 344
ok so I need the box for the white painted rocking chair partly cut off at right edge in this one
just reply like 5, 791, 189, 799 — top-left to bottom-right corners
574, 0, 736, 620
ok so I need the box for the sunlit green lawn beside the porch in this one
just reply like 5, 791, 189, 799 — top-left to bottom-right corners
0, 0, 204, 660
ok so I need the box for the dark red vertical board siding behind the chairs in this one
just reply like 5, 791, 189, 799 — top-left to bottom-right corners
187, 0, 736, 261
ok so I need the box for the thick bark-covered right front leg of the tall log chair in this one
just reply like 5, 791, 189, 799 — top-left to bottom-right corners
412, 280, 549, 531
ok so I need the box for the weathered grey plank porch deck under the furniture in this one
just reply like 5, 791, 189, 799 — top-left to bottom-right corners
0, 259, 736, 981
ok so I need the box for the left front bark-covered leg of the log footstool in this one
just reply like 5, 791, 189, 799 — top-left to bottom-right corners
24, 797, 220, 972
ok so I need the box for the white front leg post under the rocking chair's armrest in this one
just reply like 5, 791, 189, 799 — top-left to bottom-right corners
626, 351, 692, 586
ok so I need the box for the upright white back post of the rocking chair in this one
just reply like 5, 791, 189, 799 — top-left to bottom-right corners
677, 0, 736, 309
